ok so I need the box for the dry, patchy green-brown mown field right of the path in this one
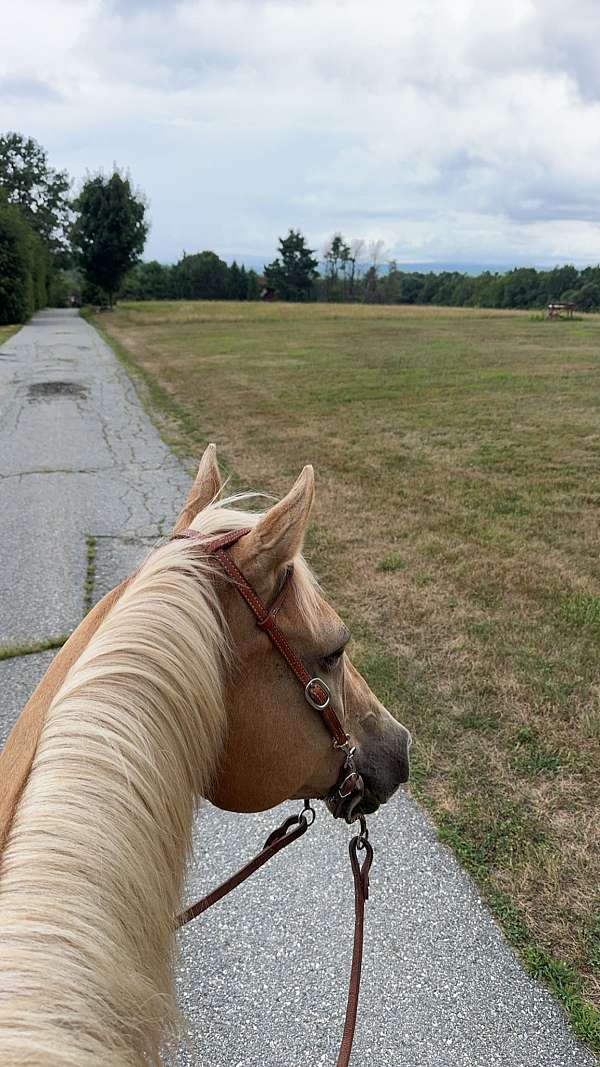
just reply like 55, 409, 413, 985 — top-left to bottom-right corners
91, 303, 600, 1050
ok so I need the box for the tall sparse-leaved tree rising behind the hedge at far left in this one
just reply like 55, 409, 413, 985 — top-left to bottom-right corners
0, 133, 72, 264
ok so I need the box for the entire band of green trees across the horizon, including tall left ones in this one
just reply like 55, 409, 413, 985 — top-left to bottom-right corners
0, 133, 600, 323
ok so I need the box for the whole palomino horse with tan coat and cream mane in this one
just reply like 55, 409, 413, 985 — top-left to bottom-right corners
0, 446, 409, 1067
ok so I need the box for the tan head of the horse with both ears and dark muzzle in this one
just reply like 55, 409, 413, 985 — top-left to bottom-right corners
174, 446, 410, 813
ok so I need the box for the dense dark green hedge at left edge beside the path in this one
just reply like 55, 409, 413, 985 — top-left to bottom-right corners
0, 203, 48, 324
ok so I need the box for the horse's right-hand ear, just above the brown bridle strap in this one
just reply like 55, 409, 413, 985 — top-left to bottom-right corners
248, 466, 315, 570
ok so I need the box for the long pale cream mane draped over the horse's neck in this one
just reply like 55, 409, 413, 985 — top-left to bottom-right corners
0, 545, 223, 1067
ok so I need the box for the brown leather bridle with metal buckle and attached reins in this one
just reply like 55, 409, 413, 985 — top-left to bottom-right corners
173, 527, 373, 1067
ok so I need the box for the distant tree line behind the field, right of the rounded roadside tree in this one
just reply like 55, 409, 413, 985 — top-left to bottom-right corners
121, 229, 600, 312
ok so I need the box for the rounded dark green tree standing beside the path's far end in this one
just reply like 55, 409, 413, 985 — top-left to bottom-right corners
72, 170, 148, 306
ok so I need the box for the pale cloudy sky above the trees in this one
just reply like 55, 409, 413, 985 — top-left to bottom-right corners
0, 0, 600, 266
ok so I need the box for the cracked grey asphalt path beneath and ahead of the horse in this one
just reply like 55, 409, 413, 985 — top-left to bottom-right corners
0, 312, 595, 1067
